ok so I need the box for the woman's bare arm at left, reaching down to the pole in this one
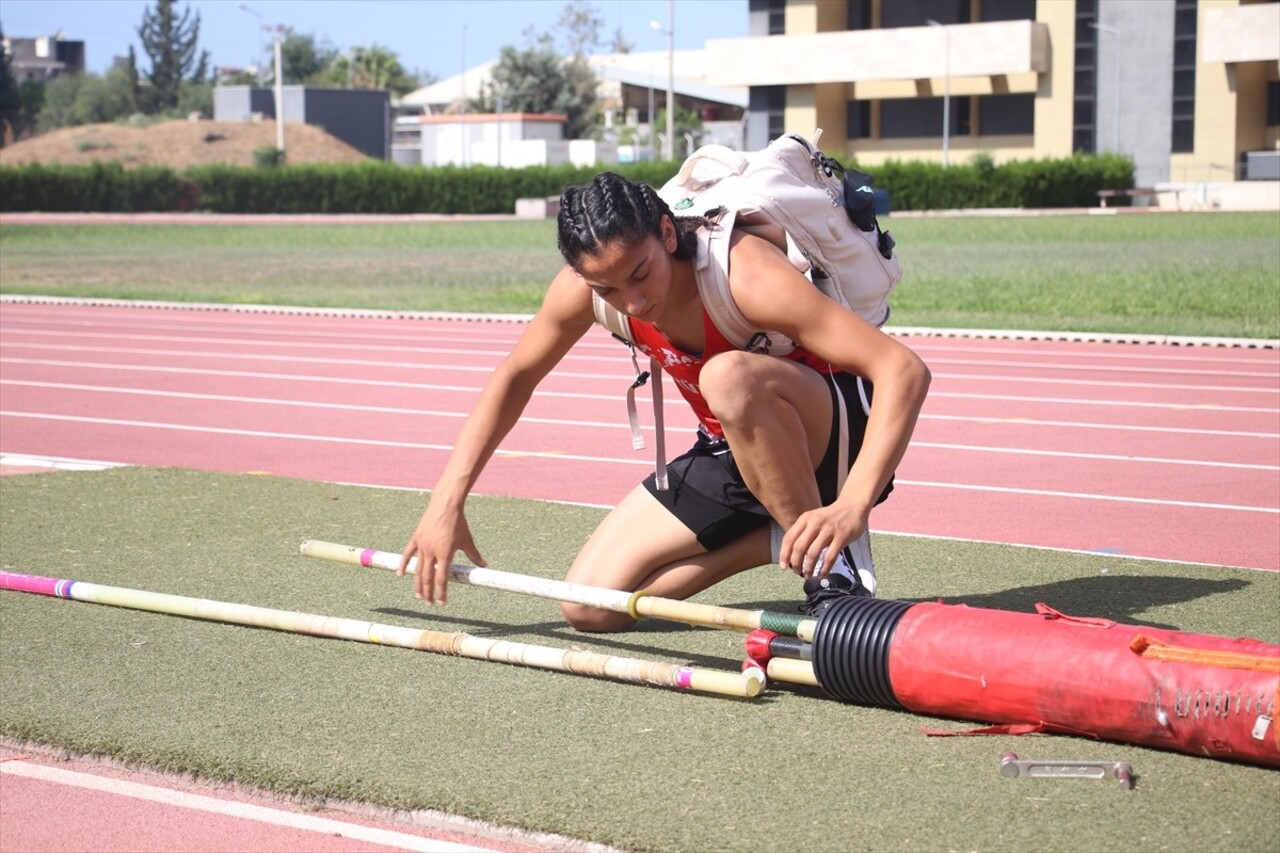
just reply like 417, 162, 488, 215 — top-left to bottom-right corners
398, 266, 594, 605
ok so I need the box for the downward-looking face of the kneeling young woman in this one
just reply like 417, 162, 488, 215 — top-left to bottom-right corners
577, 218, 676, 323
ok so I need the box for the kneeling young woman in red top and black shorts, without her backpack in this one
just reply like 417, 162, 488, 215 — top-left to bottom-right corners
401, 172, 929, 631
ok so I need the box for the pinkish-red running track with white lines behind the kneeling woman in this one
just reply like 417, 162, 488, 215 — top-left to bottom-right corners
0, 304, 1280, 570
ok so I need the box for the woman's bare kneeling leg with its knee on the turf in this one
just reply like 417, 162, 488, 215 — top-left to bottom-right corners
561, 485, 769, 631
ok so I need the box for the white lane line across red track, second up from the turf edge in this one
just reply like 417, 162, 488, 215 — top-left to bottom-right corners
0, 410, 1280, 514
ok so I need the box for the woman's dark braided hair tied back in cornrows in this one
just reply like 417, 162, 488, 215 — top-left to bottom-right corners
556, 172, 705, 269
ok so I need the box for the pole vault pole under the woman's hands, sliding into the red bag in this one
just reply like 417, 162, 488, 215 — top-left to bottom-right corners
302, 539, 818, 640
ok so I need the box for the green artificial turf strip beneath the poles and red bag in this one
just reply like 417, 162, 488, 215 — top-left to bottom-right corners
0, 469, 1280, 852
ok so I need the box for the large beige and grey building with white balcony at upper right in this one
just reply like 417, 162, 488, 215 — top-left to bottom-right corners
704, 0, 1280, 186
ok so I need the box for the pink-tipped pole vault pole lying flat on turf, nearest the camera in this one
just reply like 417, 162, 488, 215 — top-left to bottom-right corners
0, 571, 764, 698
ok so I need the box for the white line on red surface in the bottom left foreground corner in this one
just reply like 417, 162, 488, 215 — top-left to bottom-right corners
0, 761, 497, 853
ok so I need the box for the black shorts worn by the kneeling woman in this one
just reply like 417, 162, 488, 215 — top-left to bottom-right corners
644, 373, 893, 551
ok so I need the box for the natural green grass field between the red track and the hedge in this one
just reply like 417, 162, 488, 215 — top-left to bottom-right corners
0, 208, 1280, 338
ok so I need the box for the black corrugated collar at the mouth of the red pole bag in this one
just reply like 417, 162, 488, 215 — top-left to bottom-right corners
813, 597, 913, 708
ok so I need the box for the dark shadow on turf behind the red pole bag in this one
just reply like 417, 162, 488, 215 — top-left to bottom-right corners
739, 575, 1249, 630
